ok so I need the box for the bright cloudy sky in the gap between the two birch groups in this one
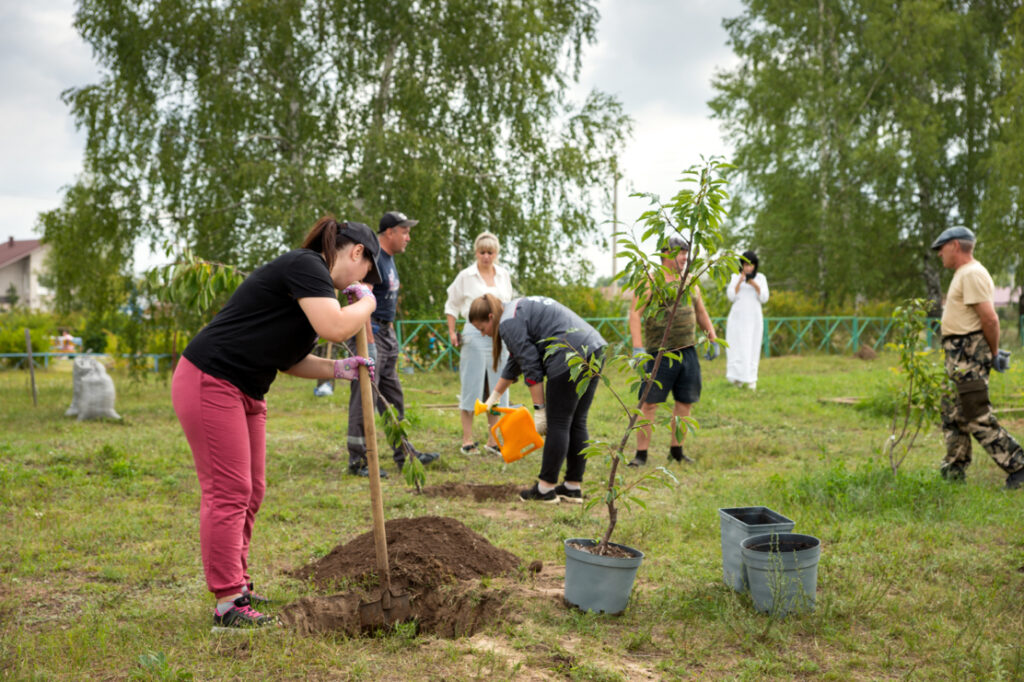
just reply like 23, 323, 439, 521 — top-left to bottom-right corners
580, 0, 742, 276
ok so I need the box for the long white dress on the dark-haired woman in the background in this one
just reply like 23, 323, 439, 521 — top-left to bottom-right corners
725, 272, 768, 388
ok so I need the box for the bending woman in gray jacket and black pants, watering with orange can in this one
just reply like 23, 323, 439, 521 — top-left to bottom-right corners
469, 294, 607, 502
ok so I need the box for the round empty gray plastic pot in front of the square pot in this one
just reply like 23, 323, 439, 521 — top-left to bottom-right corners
740, 532, 821, 615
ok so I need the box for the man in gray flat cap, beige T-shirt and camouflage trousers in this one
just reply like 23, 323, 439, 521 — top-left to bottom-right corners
932, 225, 1024, 488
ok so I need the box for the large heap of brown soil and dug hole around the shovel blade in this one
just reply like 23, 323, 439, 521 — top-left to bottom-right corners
280, 516, 522, 637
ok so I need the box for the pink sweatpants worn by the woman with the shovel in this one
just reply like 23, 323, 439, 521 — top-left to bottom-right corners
171, 357, 266, 599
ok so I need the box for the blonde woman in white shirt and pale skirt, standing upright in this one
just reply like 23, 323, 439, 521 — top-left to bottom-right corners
444, 232, 513, 456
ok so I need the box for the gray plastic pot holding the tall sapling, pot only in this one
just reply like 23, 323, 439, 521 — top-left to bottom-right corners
565, 538, 643, 614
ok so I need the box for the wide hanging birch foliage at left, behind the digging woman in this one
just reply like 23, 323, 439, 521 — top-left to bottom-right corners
42, 0, 630, 337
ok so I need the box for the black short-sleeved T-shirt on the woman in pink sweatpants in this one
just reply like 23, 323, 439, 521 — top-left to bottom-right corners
183, 249, 337, 400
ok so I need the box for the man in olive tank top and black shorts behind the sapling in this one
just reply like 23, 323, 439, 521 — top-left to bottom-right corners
629, 236, 718, 467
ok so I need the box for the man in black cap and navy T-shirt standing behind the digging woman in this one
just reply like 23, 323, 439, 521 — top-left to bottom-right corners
348, 211, 440, 476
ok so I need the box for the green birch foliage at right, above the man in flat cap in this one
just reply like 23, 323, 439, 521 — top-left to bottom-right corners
712, 0, 1020, 309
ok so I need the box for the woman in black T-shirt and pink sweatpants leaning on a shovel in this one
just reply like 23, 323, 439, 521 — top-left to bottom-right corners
171, 216, 380, 628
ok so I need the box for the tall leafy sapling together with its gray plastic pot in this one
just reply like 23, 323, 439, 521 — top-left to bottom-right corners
548, 159, 738, 613
